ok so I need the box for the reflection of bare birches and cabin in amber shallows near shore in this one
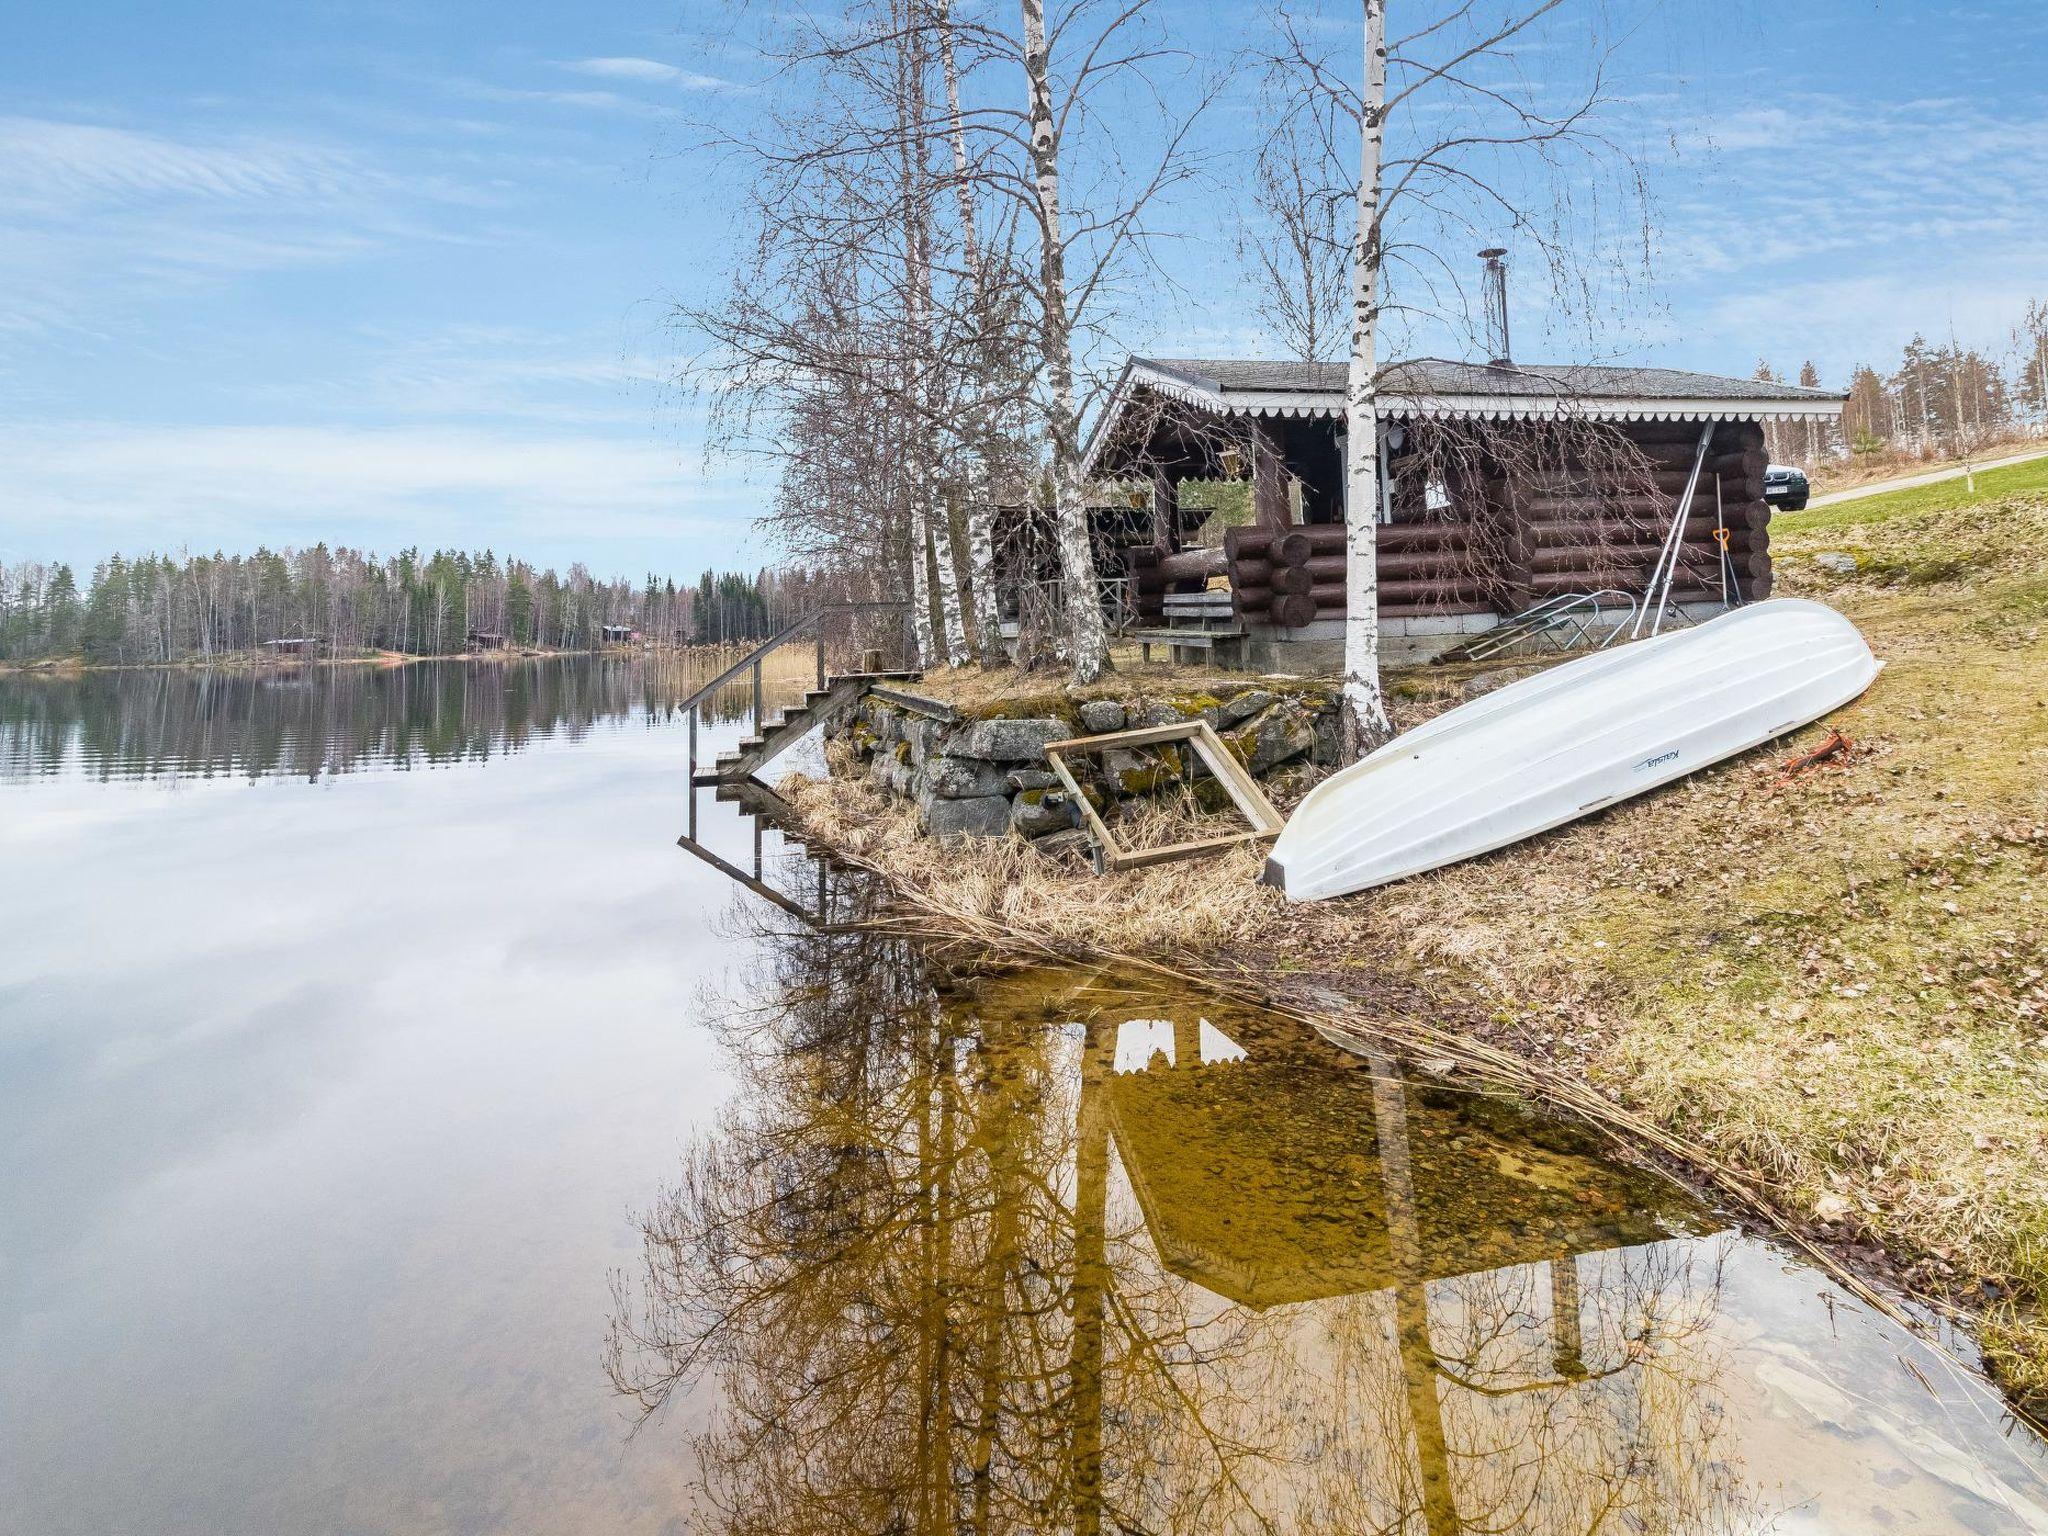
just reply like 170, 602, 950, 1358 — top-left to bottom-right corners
608, 893, 1757, 1534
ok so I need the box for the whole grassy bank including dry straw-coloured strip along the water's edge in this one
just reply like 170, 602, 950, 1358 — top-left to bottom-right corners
784, 465, 2048, 1415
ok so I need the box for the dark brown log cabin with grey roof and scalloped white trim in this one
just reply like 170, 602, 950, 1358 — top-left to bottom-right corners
1085, 358, 1843, 670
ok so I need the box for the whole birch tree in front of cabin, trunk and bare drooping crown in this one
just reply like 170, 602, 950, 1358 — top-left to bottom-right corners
1255, 0, 1653, 756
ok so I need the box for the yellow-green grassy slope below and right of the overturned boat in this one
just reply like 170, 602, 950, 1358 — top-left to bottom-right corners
1382, 461, 2048, 1393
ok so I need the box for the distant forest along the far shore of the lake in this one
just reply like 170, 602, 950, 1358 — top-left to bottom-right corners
0, 545, 847, 664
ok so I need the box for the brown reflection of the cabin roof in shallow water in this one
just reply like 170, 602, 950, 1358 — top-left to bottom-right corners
1108, 1016, 1690, 1309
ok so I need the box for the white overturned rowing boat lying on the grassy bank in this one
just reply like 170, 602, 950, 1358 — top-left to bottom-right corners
1266, 598, 1882, 901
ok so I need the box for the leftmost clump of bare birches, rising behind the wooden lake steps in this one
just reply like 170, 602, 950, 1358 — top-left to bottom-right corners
676, 0, 1026, 666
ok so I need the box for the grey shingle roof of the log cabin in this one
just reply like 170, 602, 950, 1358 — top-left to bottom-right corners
1133, 356, 1843, 406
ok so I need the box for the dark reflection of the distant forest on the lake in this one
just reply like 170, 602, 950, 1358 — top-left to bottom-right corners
0, 657, 770, 778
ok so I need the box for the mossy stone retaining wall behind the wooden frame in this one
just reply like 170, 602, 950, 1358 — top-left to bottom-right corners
825, 680, 1337, 846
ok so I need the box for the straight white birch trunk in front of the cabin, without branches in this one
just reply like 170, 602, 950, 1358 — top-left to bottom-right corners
1343, 0, 1393, 762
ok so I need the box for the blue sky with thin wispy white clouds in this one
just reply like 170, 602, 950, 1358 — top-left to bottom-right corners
0, 0, 2048, 578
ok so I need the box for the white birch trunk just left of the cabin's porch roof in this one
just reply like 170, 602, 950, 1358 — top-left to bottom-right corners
1022, 0, 1105, 682
